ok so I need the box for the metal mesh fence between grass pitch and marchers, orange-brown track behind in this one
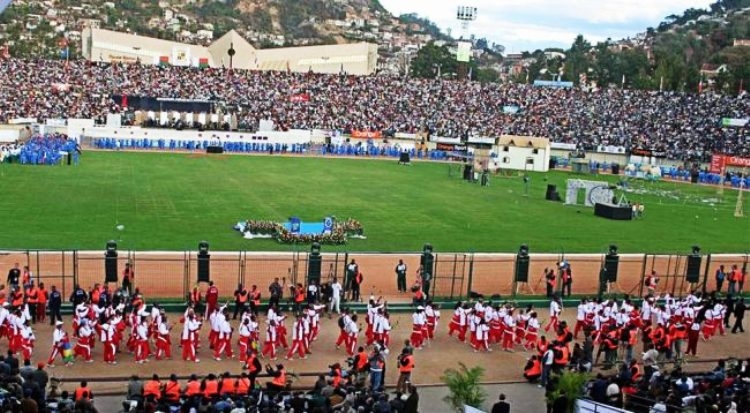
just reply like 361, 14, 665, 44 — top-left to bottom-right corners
0, 250, 749, 301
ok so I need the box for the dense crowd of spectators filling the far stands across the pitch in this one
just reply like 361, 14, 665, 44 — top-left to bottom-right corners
0, 59, 750, 160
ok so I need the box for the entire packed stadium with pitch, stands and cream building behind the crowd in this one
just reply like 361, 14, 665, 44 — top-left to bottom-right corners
0, 5, 750, 411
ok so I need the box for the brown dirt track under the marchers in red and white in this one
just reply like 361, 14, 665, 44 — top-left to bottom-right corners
22, 309, 750, 392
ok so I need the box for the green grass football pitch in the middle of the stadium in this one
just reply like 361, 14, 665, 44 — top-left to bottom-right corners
0, 152, 750, 253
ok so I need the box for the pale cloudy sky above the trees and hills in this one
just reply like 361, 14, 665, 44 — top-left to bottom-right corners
380, 0, 714, 53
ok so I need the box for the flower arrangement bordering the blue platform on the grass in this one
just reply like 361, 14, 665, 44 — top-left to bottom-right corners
244, 218, 364, 245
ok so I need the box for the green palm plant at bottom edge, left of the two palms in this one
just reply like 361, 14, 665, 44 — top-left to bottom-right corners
440, 363, 487, 411
